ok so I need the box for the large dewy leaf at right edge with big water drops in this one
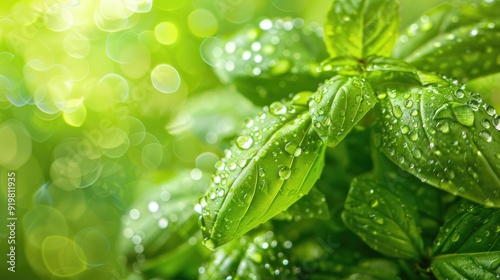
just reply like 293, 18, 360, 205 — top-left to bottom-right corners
374, 75, 500, 207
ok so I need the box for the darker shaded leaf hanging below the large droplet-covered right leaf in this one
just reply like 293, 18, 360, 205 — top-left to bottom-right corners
342, 176, 423, 261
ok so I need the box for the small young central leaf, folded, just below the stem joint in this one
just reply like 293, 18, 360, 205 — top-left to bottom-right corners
309, 75, 377, 147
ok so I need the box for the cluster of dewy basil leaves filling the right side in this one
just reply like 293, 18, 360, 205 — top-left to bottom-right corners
127, 0, 500, 279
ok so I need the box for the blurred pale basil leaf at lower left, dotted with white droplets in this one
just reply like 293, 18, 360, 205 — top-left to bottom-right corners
118, 171, 210, 261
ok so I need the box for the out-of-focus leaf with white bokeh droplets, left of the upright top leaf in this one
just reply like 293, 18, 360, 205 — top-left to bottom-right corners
201, 19, 327, 106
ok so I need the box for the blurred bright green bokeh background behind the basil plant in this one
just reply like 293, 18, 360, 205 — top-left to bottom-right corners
0, 0, 500, 280
